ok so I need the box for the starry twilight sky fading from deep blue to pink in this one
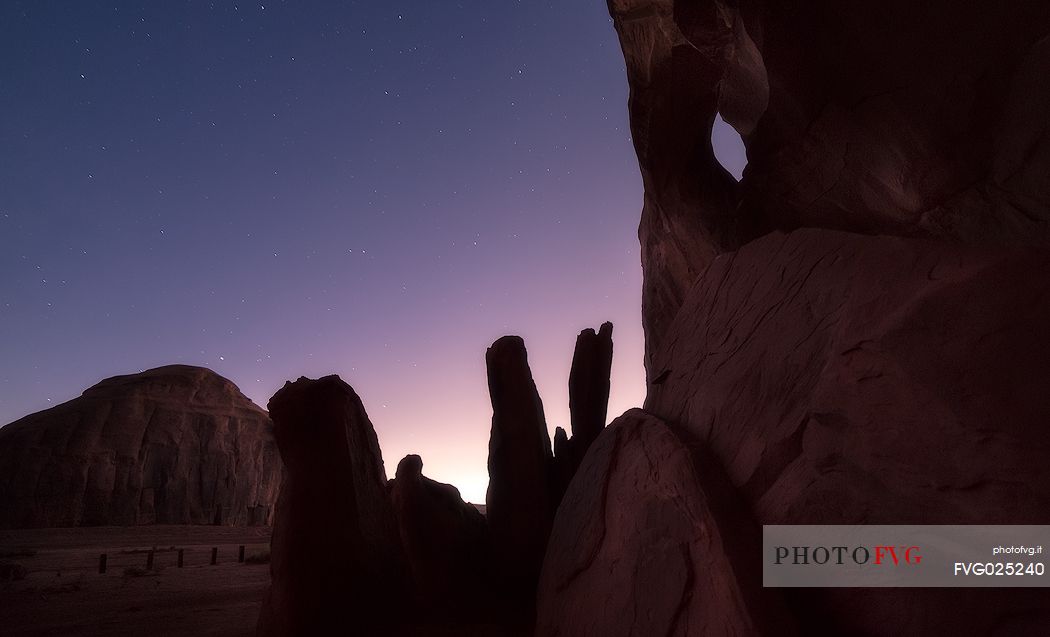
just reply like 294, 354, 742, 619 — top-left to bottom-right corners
0, 0, 742, 502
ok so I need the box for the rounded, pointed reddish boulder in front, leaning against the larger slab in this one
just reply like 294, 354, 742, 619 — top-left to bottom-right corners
537, 409, 793, 637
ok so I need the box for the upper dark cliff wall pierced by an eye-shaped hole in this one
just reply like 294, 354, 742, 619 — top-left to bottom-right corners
609, 0, 1050, 367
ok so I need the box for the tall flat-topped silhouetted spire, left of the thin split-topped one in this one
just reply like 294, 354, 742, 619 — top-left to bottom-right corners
485, 336, 553, 598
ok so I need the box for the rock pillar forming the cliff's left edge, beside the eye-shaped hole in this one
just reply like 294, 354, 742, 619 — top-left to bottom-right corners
609, 0, 742, 363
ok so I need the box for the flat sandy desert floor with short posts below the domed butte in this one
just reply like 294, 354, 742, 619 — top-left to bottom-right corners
0, 526, 270, 637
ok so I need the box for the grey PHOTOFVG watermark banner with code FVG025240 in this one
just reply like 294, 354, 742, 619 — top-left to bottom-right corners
762, 525, 1050, 588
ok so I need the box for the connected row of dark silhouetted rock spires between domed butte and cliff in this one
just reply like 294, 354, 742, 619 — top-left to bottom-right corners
258, 323, 612, 637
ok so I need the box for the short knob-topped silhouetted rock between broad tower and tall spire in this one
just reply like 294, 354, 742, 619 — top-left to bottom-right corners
391, 455, 488, 616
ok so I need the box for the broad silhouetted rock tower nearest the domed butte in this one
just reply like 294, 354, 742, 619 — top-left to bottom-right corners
258, 376, 407, 637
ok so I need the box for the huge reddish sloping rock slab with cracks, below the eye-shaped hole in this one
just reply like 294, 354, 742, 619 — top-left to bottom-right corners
646, 230, 1050, 635
